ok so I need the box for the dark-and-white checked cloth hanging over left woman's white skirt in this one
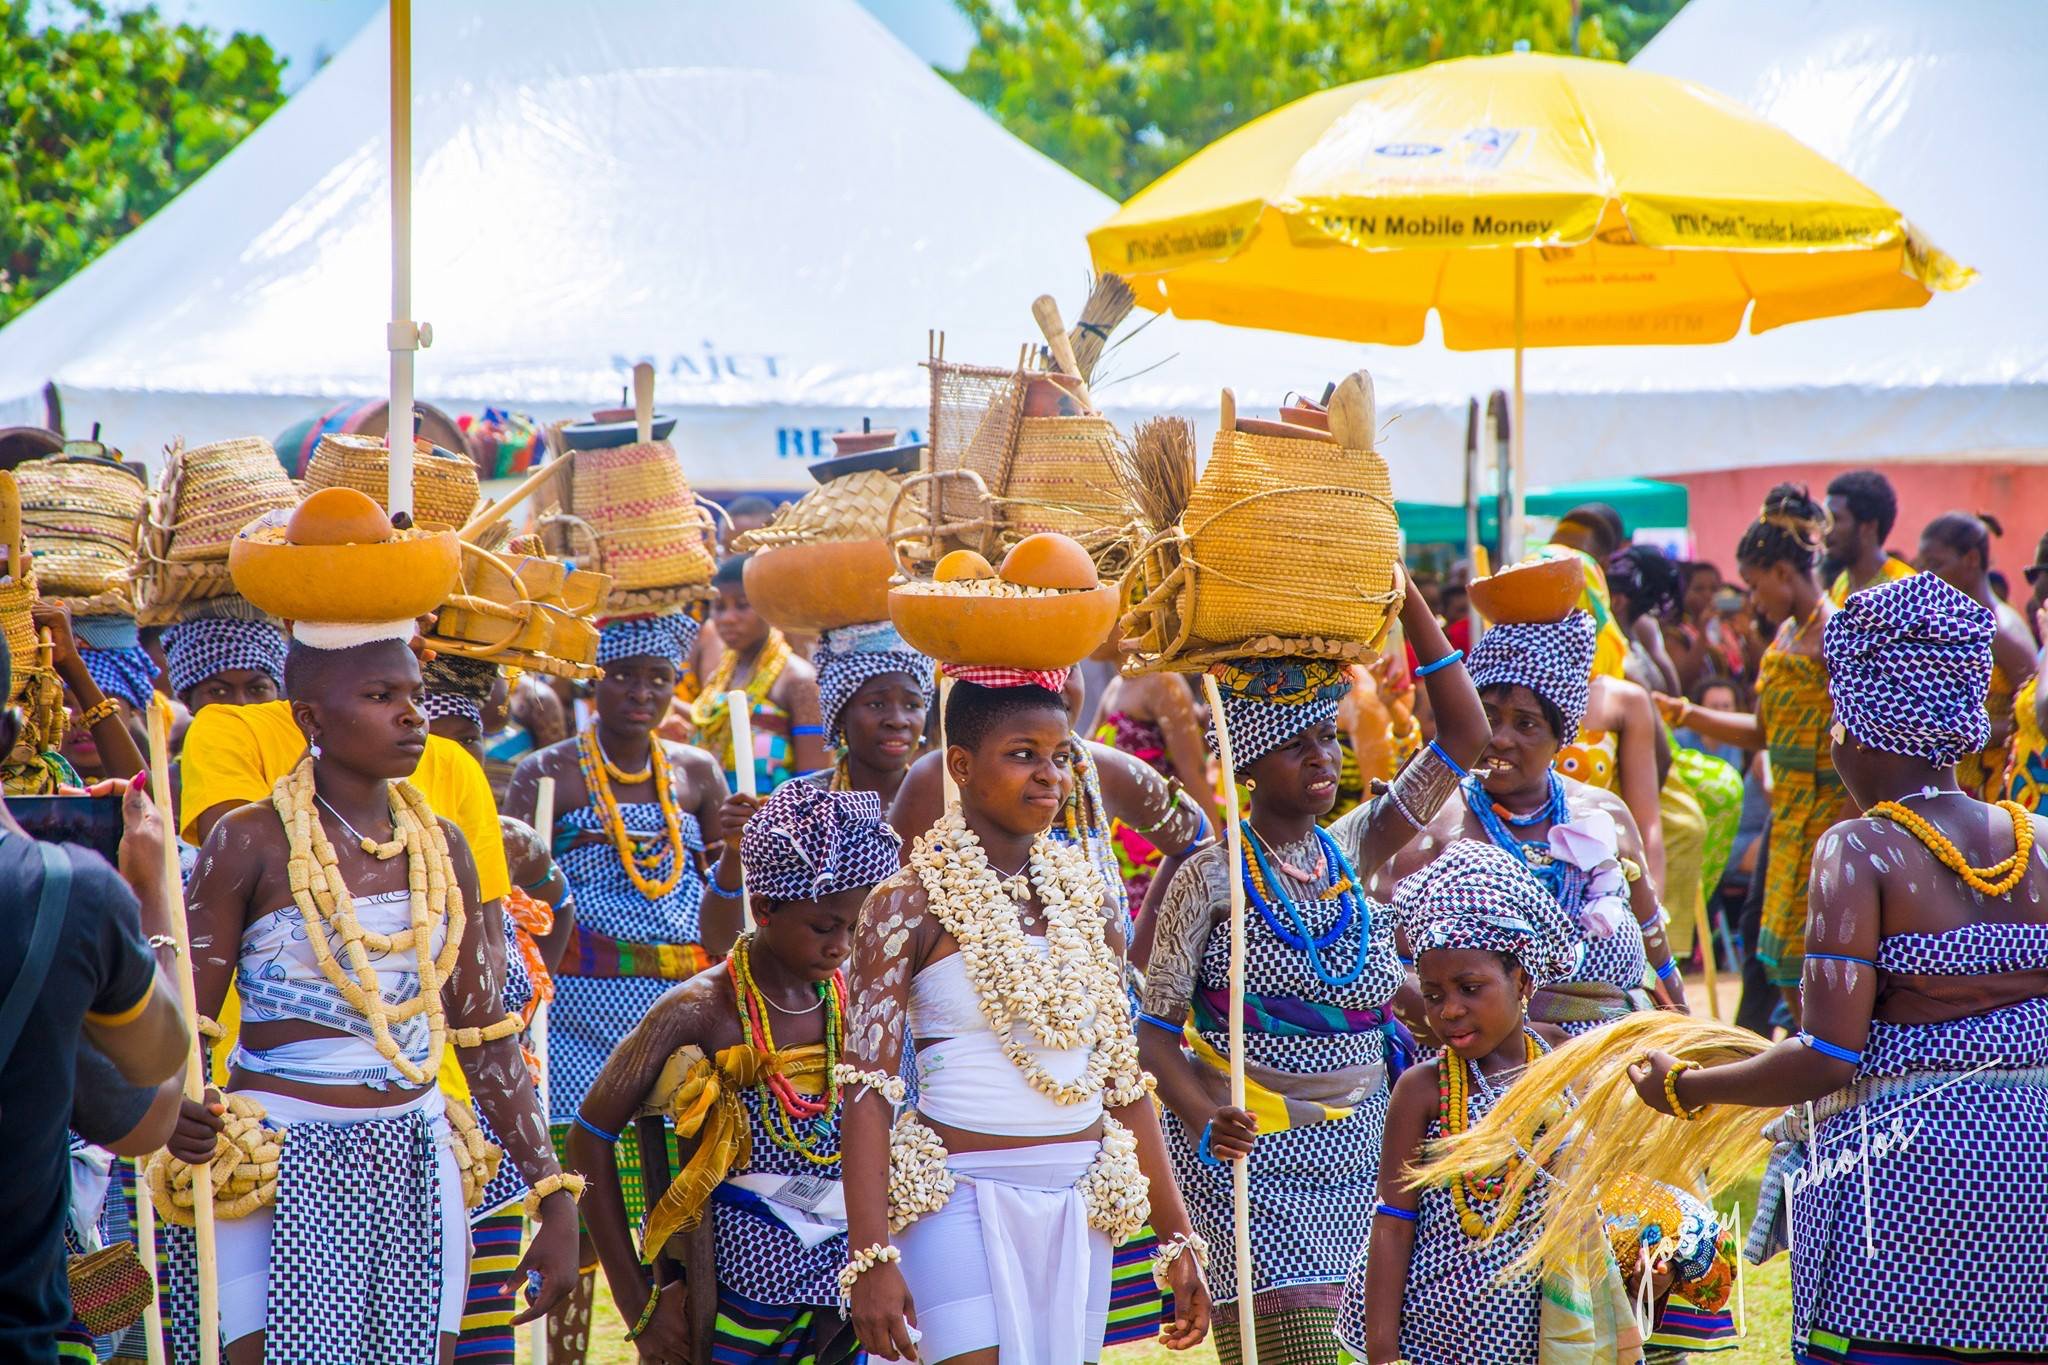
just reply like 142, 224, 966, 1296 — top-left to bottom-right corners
264, 1111, 444, 1365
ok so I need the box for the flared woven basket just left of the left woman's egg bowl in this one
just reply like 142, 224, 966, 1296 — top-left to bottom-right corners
135, 436, 299, 626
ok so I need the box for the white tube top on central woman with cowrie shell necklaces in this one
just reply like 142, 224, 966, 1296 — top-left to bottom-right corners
909, 935, 1102, 1138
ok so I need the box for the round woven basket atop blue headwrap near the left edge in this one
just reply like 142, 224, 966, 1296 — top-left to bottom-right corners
14, 456, 150, 616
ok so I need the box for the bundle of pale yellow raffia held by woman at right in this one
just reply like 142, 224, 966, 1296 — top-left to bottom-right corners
1415, 1011, 1772, 1273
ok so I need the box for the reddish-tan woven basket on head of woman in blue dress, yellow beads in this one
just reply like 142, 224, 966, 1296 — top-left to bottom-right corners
549, 440, 717, 589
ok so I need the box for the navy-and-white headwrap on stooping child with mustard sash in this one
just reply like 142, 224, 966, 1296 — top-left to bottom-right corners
739, 782, 903, 900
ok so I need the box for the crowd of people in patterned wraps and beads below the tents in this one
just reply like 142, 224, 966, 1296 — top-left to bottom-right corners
16, 446, 2048, 1365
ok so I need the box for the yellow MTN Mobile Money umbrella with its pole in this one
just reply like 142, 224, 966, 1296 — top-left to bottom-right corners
1087, 53, 1972, 544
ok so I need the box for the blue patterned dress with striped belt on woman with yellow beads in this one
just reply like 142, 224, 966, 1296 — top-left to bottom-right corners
547, 802, 705, 1124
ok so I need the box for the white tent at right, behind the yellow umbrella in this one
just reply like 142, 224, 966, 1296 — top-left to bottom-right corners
1441, 0, 2048, 483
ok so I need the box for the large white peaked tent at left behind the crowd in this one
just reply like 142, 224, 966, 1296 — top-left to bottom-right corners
0, 0, 1464, 497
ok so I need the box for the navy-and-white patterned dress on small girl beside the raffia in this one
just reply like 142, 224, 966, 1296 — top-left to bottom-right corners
1327, 1040, 1548, 1365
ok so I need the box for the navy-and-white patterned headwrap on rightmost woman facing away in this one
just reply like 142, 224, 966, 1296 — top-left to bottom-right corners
1821, 573, 1999, 767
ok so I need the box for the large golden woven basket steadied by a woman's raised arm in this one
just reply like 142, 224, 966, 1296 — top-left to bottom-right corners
1122, 428, 1401, 671
